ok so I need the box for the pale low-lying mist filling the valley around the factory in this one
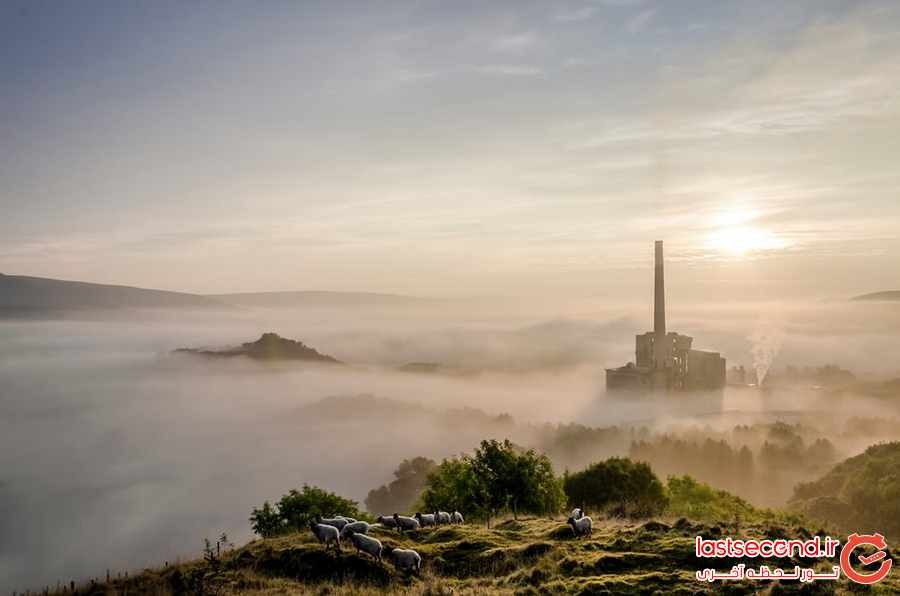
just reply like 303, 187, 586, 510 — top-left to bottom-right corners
0, 303, 900, 589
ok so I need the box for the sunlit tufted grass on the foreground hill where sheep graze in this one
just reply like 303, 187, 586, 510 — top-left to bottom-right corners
58, 512, 900, 596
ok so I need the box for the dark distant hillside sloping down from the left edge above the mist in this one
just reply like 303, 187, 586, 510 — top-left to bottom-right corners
0, 274, 227, 317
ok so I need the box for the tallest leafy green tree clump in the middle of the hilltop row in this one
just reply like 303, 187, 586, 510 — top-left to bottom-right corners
420, 440, 565, 525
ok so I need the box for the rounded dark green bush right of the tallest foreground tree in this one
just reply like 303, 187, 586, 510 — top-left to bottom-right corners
563, 457, 667, 517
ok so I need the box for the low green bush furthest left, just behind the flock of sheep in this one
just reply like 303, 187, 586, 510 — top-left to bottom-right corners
250, 484, 362, 538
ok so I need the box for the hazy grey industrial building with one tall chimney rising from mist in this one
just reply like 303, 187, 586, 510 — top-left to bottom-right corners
606, 240, 725, 392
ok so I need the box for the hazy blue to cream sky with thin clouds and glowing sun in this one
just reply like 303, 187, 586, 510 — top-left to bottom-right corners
0, 0, 900, 300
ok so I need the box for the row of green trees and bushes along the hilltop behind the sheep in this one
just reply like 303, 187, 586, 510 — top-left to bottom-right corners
250, 440, 752, 537
